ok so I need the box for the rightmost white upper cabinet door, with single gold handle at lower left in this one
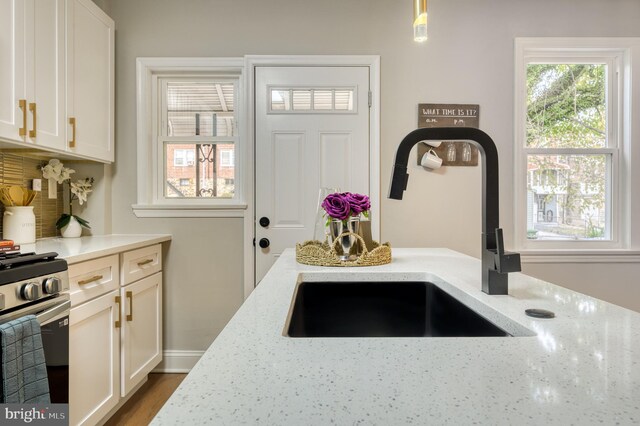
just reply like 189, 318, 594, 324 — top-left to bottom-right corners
66, 0, 115, 162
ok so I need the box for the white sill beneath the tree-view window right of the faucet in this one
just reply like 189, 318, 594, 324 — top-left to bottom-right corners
520, 249, 640, 263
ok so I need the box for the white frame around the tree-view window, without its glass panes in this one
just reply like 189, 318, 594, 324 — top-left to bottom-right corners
514, 38, 640, 262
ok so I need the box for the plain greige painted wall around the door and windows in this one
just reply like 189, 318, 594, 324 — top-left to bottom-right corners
108, 0, 640, 358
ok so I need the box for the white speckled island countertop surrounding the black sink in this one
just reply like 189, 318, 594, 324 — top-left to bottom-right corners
153, 249, 640, 425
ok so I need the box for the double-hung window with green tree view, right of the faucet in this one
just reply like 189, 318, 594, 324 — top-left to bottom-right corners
514, 39, 640, 251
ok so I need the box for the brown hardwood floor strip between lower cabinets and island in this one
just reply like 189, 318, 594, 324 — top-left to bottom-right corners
105, 374, 187, 426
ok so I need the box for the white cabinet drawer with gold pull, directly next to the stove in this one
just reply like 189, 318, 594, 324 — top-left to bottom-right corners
69, 254, 120, 306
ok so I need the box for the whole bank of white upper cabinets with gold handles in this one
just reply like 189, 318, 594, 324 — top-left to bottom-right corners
0, 0, 115, 162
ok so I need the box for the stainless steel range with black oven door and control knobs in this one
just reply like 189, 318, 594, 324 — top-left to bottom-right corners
0, 252, 71, 403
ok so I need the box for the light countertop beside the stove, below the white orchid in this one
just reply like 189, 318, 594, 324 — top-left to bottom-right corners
20, 234, 171, 264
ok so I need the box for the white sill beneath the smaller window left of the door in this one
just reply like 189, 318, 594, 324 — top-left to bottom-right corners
131, 204, 247, 218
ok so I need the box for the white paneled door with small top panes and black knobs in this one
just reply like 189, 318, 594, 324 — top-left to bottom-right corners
255, 66, 370, 282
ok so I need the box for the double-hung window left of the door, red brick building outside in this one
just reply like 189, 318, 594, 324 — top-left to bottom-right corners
157, 76, 238, 199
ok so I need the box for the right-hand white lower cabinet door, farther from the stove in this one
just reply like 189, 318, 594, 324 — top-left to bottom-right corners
120, 272, 162, 396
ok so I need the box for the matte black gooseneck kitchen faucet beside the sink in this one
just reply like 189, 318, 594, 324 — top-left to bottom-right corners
389, 127, 521, 294
